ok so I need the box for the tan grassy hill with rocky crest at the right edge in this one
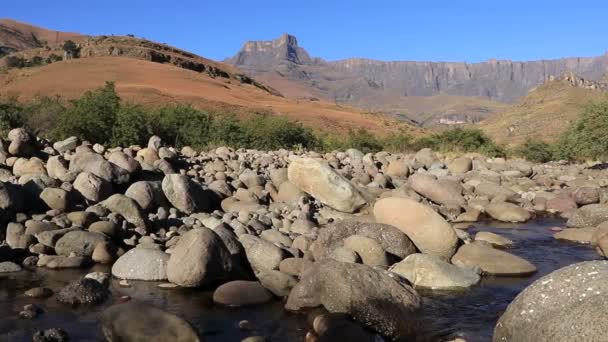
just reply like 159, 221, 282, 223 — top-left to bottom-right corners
479, 73, 608, 145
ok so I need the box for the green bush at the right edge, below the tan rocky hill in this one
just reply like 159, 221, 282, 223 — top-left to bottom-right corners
555, 100, 608, 161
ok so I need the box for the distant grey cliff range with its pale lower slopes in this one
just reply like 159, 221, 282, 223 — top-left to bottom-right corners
227, 35, 608, 123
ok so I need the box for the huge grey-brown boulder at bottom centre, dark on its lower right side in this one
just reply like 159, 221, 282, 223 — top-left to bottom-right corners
285, 260, 420, 340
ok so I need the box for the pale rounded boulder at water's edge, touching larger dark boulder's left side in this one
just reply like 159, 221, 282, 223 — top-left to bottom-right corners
112, 248, 169, 281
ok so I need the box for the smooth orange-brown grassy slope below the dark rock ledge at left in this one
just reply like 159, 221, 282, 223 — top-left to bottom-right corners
0, 57, 421, 134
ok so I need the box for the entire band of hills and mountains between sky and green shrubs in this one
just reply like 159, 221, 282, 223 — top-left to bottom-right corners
0, 19, 608, 144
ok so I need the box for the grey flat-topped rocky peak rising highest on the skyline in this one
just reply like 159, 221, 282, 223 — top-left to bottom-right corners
226, 33, 314, 70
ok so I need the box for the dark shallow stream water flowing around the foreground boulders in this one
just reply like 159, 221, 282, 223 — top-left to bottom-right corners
0, 218, 598, 342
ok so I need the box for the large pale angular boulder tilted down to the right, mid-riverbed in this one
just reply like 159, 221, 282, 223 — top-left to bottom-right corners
287, 158, 367, 213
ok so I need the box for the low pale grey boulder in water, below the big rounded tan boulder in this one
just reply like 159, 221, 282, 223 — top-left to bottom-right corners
389, 253, 480, 290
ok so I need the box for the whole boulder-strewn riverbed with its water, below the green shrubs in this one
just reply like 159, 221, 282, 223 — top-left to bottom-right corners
0, 129, 608, 341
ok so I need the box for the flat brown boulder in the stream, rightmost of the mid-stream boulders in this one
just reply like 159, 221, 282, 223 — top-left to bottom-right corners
452, 242, 536, 276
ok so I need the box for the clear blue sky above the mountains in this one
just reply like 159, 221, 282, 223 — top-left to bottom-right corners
0, 0, 608, 62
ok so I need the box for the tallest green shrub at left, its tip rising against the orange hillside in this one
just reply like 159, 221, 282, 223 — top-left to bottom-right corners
54, 82, 120, 144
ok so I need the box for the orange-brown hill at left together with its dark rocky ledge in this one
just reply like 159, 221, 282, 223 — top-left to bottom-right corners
0, 20, 422, 135
